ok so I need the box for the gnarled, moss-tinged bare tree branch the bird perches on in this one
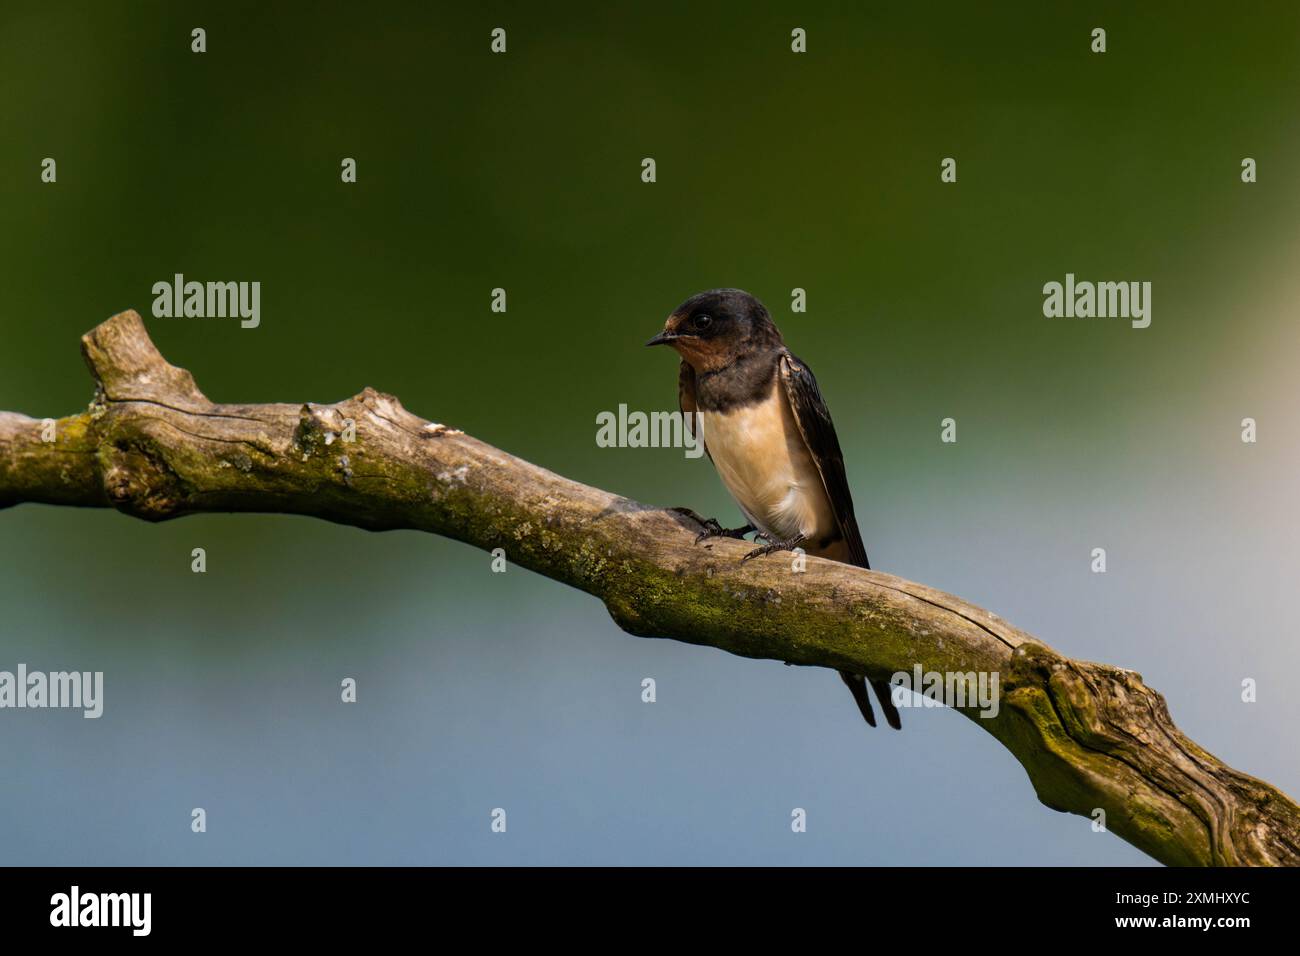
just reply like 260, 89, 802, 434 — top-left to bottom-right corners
0, 312, 1300, 865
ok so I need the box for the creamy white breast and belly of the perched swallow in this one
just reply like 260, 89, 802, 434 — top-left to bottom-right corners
702, 380, 835, 540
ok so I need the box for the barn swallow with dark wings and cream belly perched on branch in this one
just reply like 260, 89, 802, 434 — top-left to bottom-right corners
646, 289, 901, 730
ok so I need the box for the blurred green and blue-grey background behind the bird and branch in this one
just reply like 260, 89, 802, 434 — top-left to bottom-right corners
0, 3, 1300, 864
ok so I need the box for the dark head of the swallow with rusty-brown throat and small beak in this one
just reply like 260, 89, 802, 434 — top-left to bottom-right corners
646, 289, 781, 372
